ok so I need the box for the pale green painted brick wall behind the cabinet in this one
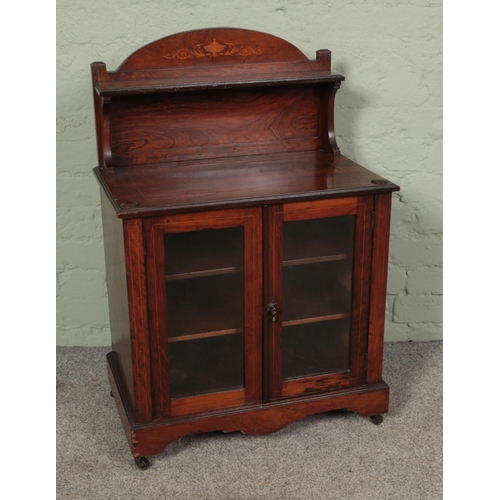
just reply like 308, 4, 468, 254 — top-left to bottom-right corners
57, 0, 442, 346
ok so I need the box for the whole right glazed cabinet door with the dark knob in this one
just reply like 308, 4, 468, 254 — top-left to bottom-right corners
264, 196, 373, 400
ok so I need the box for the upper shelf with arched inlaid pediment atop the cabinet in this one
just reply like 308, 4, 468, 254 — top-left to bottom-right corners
92, 28, 344, 97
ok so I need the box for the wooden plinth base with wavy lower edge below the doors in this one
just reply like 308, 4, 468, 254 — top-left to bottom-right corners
107, 352, 389, 457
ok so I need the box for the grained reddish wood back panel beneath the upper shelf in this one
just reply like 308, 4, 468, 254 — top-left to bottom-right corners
110, 87, 318, 167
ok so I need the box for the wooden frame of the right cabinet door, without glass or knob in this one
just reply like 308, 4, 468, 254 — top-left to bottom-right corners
263, 196, 373, 401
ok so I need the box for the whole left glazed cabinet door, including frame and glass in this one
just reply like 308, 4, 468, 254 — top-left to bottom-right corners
145, 208, 262, 418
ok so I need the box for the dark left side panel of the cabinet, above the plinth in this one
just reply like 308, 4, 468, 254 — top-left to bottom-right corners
101, 189, 134, 414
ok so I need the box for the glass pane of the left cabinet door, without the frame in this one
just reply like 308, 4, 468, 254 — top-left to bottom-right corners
165, 227, 244, 398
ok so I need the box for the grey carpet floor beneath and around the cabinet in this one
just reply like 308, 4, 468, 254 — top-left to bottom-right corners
57, 342, 443, 500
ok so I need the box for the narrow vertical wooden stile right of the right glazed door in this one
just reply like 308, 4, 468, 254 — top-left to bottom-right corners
366, 193, 392, 384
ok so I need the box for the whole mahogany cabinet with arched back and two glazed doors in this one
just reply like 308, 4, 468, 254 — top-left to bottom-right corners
92, 28, 399, 469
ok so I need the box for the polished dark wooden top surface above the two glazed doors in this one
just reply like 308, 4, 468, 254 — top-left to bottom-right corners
94, 151, 399, 218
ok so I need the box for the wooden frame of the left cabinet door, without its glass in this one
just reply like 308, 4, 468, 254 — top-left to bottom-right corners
144, 207, 262, 418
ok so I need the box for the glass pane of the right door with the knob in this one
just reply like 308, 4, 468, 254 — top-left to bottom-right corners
282, 215, 355, 380
